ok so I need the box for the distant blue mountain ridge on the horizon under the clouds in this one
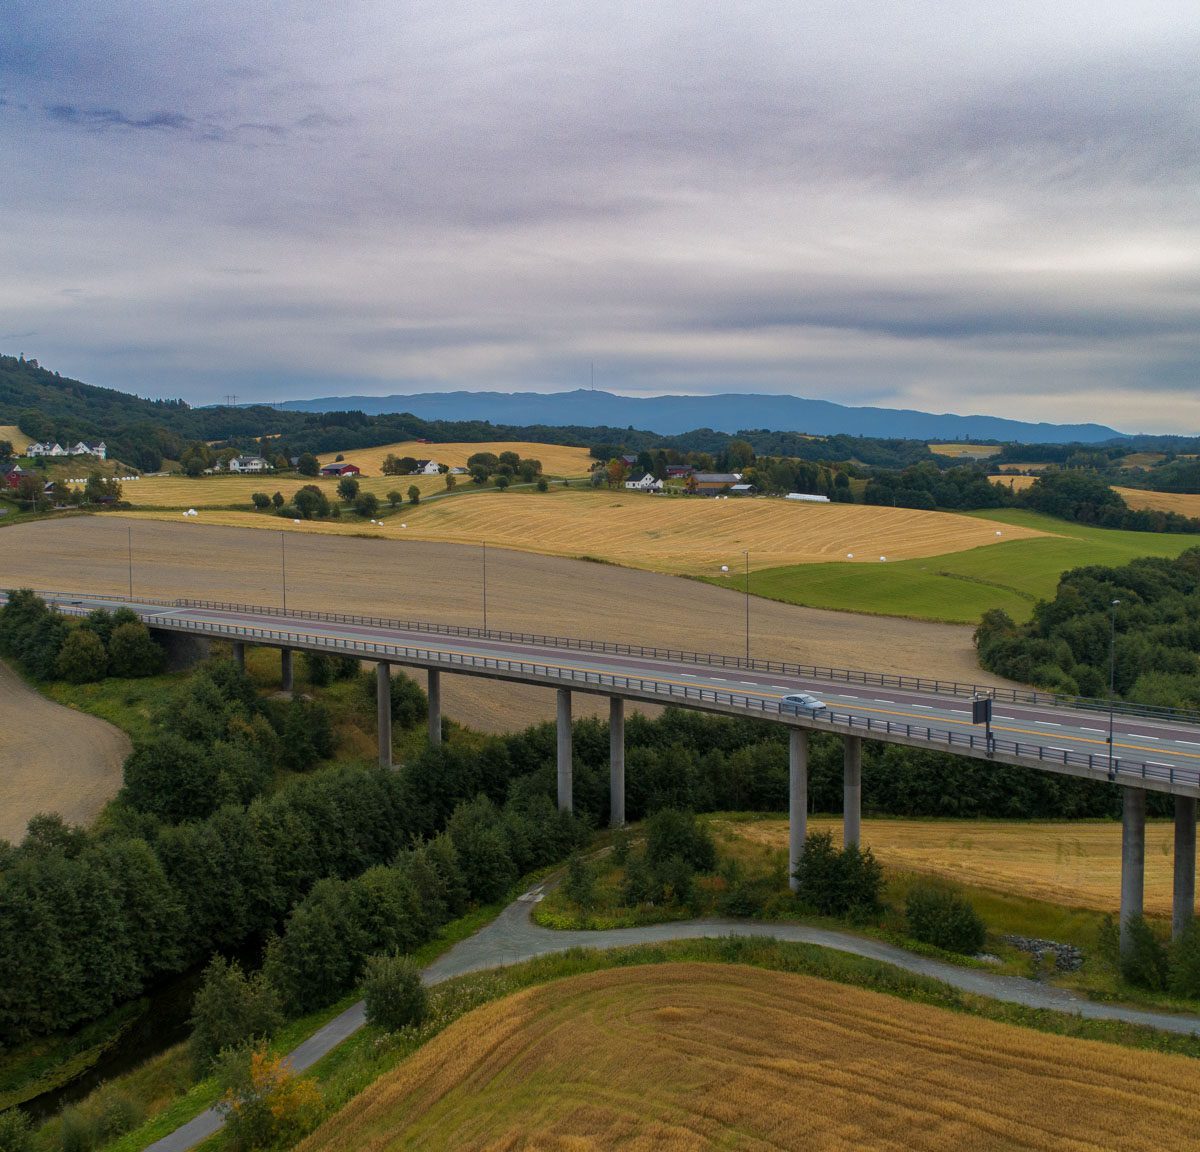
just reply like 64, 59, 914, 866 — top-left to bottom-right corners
278, 389, 1126, 444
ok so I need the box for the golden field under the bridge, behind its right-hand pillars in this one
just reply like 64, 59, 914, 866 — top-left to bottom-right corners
720, 816, 1175, 916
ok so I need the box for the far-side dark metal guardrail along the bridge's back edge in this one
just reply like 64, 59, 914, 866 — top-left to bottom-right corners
28, 592, 1200, 725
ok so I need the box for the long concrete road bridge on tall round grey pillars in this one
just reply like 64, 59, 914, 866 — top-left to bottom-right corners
32, 592, 1200, 944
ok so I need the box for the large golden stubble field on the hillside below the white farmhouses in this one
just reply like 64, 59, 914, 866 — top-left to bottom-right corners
114, 487, 1044, 573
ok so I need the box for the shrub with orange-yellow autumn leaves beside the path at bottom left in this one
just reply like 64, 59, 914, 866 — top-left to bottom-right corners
216, 1048, 322, 1150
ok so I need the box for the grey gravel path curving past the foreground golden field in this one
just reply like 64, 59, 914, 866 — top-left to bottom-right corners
146, 884, 1200, 1152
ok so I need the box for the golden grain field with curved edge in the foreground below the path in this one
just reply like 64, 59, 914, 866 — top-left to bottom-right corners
299, 964, 1198, 1152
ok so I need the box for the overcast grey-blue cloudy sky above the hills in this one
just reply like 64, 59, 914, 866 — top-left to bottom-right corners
0, 0, 1200, 432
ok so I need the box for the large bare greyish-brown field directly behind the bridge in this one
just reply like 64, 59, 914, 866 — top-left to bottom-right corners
0, 520, 1017, 731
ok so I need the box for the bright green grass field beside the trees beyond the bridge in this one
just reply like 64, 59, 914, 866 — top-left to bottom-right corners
739, 509, 1200, 624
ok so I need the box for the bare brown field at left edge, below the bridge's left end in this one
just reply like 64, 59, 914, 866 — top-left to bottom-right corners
0, 661, 131, 842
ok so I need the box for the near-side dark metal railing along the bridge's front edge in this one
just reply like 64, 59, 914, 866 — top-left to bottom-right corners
60, 607, 1200, 788
